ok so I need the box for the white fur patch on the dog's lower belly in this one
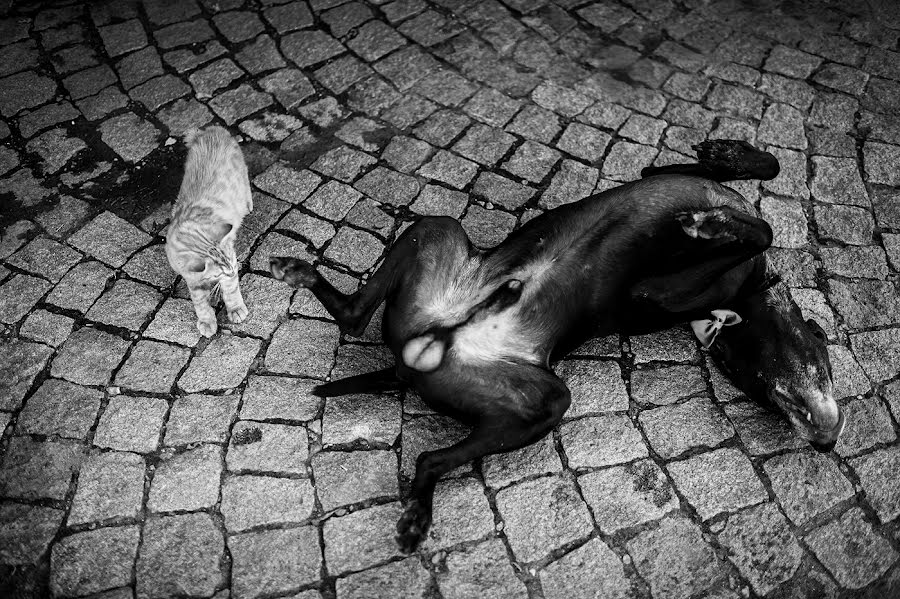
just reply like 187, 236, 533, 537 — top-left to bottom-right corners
453, 308, 538, 363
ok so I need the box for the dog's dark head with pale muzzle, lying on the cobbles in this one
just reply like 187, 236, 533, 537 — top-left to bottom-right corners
710, 285, 844, 451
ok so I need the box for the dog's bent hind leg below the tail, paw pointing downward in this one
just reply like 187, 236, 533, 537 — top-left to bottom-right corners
397, 365, 571, 553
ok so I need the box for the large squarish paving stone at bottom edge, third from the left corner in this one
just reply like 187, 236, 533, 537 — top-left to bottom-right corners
136, 514, 225, 599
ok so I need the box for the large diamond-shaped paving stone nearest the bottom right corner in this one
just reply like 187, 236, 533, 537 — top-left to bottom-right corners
806, 508, 898, 589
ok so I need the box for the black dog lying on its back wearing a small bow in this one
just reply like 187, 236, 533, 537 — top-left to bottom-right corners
271, 141, 843, 551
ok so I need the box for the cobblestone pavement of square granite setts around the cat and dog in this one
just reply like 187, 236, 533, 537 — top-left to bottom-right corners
0, 0, 900, 599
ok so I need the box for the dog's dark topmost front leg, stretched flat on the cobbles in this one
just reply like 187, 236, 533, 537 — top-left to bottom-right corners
641, 139, 781, 181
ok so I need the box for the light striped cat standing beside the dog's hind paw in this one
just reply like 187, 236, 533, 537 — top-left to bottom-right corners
166, 127, 253, 337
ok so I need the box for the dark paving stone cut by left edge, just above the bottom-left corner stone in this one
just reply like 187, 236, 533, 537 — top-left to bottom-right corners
0, 503, 64, 566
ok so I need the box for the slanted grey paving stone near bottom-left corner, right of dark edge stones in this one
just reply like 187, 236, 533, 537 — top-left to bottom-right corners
50, 526, 140, 597
